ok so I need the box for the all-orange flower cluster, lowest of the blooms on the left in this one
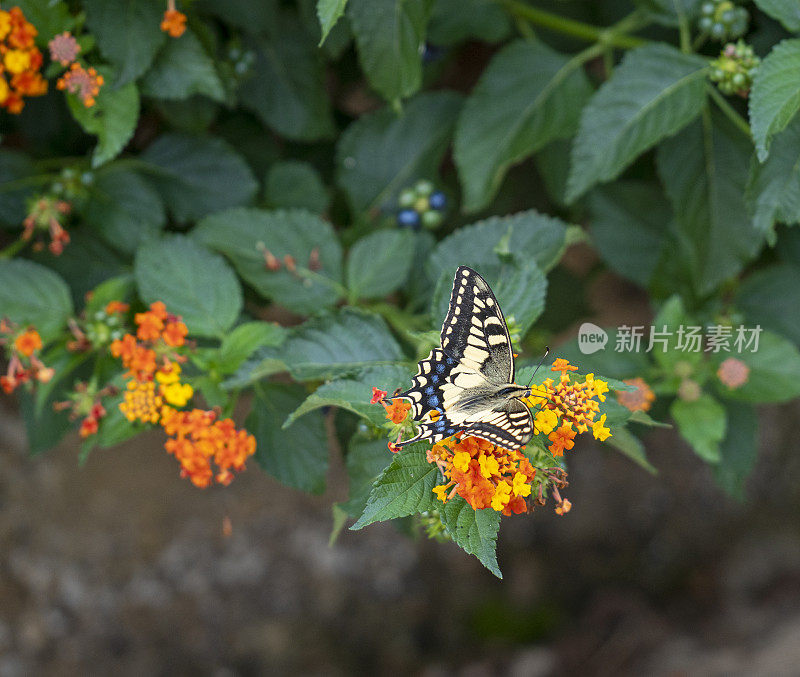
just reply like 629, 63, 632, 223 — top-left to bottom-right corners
161, 407, 256, 488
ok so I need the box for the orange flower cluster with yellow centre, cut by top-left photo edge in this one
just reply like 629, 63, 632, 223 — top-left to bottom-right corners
0, 7, 47, 113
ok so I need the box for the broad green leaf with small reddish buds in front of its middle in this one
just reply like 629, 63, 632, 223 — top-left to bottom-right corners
194, 209, 342, 314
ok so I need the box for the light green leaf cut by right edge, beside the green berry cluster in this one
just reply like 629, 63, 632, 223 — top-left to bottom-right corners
749, 40, 800, 162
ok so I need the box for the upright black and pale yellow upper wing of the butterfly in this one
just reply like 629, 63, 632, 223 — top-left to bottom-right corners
441, 266, 514, 385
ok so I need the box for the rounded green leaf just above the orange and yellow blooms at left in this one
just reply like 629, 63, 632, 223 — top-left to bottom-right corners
134, 235, 242, 338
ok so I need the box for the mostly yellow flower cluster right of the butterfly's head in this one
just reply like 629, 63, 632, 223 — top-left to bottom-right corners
524, 358, 611, 456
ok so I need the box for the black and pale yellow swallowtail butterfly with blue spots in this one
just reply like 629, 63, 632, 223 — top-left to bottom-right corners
397, 266, 533, 449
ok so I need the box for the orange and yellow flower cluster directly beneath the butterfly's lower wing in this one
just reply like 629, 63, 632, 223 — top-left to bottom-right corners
428, 435, 536, 515
